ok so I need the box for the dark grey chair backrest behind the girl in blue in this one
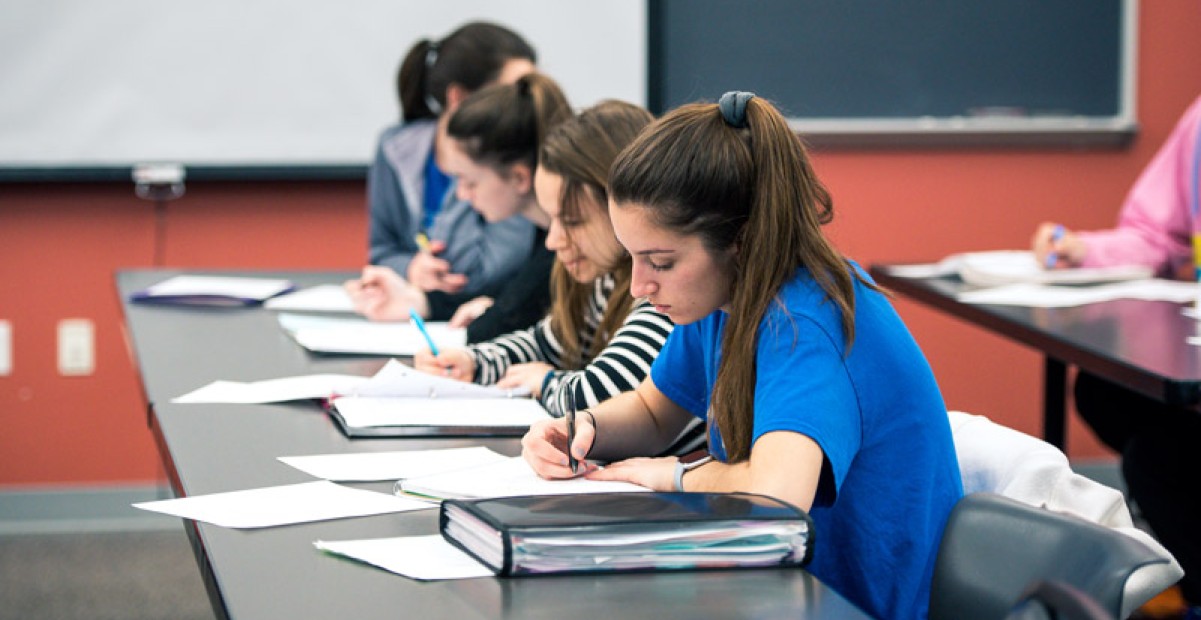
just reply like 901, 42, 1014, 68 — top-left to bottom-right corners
930, 493, 1171, 620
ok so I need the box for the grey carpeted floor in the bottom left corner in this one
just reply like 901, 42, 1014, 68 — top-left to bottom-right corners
0, 526, 214, 620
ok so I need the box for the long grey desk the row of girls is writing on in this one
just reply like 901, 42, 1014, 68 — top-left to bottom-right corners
116, 270, 866, 620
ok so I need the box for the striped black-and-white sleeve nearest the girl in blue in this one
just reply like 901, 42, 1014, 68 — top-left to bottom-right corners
542, 302, 674, 417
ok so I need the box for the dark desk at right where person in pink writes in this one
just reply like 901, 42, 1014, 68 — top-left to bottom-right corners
870, 264, 1201, 449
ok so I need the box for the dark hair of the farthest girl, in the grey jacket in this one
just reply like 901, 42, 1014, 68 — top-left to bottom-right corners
396, 22, 538, 123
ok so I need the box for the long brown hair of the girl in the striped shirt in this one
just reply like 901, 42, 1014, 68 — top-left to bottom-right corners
538, 101, 655, 368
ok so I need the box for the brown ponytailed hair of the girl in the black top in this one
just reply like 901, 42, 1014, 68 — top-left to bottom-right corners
447, 73, 572, 174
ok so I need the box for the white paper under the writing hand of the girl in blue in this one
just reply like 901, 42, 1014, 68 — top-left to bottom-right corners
398, 457, 650, 499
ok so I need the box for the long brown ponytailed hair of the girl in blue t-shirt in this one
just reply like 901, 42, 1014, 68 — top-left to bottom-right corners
609, 97, 874, 463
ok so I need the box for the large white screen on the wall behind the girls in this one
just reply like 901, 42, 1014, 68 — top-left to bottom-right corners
0, 0, 646, 178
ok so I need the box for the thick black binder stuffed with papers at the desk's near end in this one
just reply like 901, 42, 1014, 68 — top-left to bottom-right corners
438, 493, 813, 577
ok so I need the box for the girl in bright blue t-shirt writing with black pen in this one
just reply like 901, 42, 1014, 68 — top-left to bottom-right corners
522, 93, 962, 619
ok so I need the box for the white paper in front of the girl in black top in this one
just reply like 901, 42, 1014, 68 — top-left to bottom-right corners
279, 314, 467, 356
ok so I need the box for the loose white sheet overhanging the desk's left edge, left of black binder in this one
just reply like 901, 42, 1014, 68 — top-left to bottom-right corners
133, 481, 432, 527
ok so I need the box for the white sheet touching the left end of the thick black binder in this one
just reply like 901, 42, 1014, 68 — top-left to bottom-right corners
312, 535, 492, 580
